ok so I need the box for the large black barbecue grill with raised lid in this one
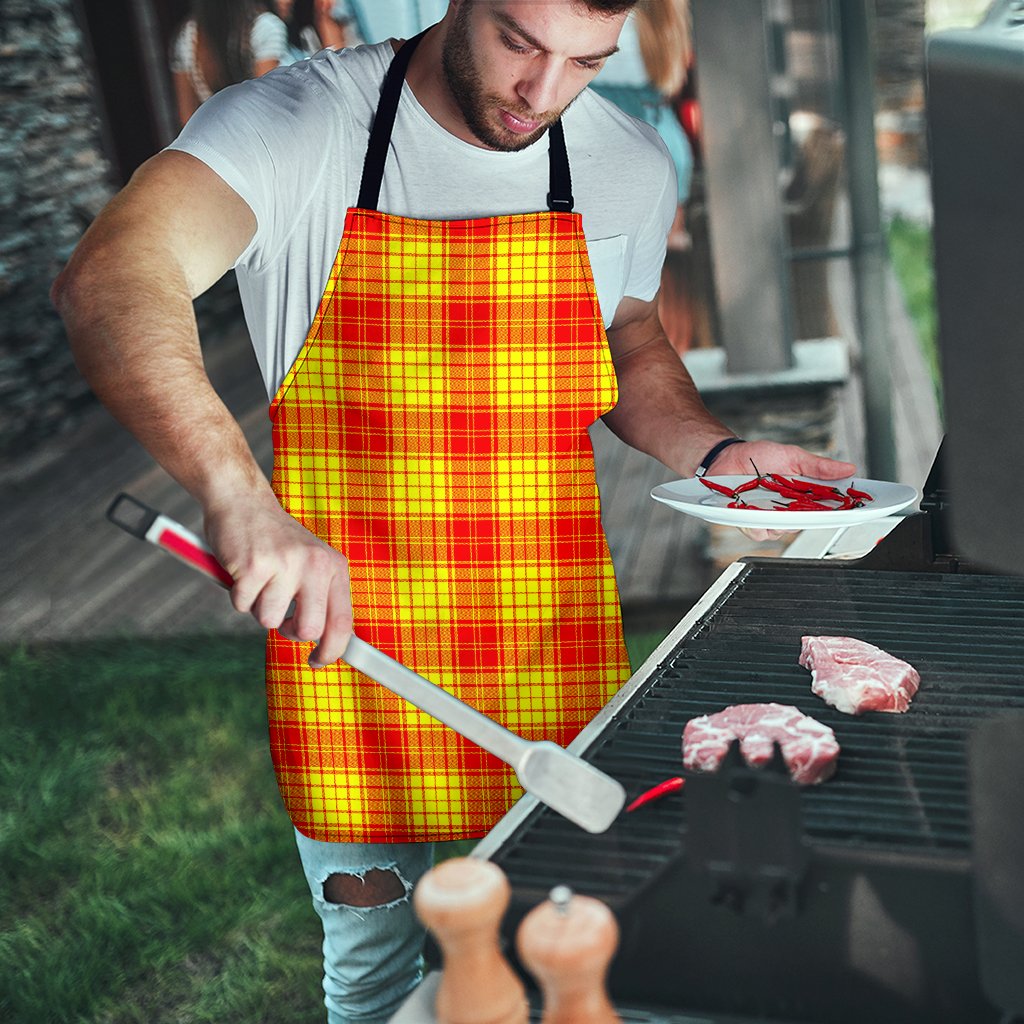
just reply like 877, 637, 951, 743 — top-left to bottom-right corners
393, 9, 1024, 1024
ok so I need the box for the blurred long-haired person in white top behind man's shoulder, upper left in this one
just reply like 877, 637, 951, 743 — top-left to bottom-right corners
171, 0, 289, 125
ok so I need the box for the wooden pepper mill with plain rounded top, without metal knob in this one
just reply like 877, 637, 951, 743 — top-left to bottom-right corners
413, 857, 529, 1024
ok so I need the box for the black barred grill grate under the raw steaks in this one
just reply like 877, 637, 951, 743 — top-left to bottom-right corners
492, 561, 1024, 900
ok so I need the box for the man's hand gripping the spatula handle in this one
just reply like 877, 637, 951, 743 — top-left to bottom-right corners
205, 495, 352, 669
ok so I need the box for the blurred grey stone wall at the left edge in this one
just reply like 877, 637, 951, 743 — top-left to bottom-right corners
0, 0, 113, 460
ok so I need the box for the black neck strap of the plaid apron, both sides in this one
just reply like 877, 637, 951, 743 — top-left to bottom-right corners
356, 29, 573, 213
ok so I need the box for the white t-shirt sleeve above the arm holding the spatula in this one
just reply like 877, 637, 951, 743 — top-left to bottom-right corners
168, 61, 348, 271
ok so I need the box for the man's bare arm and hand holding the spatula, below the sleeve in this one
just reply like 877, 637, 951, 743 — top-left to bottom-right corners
52, 152, 351, 664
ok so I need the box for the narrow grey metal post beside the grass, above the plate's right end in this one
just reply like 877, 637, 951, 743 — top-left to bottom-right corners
837, 0, 897, 480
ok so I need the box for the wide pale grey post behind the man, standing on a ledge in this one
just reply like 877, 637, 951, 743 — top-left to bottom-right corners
692, 0, 793, 373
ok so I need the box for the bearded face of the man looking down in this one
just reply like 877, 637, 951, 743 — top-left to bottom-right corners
442, 0, 626, 151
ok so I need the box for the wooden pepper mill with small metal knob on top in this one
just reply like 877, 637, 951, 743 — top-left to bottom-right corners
516, 886, 621, 1024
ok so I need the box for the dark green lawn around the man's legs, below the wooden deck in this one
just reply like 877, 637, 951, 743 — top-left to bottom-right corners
0, 635, 662, 1024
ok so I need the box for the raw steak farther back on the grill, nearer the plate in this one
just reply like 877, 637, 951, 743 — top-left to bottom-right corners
800, 637, 921, 715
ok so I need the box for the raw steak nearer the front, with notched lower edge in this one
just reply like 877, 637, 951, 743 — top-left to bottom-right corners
683, 703, 839, 785
